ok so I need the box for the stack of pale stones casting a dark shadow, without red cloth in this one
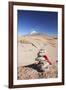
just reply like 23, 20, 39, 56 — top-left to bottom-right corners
36, 49, 49, 72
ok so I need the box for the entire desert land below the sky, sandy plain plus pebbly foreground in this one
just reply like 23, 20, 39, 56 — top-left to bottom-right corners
17, 35, 58, 79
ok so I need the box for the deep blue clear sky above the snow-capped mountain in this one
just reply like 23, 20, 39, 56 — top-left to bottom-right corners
17, 10, 58, 36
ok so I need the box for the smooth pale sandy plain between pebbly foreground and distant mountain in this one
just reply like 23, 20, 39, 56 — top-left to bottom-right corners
18, 36, 57, 67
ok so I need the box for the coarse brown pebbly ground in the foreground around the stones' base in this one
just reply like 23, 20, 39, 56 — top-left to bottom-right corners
18, 64, 58, 80
